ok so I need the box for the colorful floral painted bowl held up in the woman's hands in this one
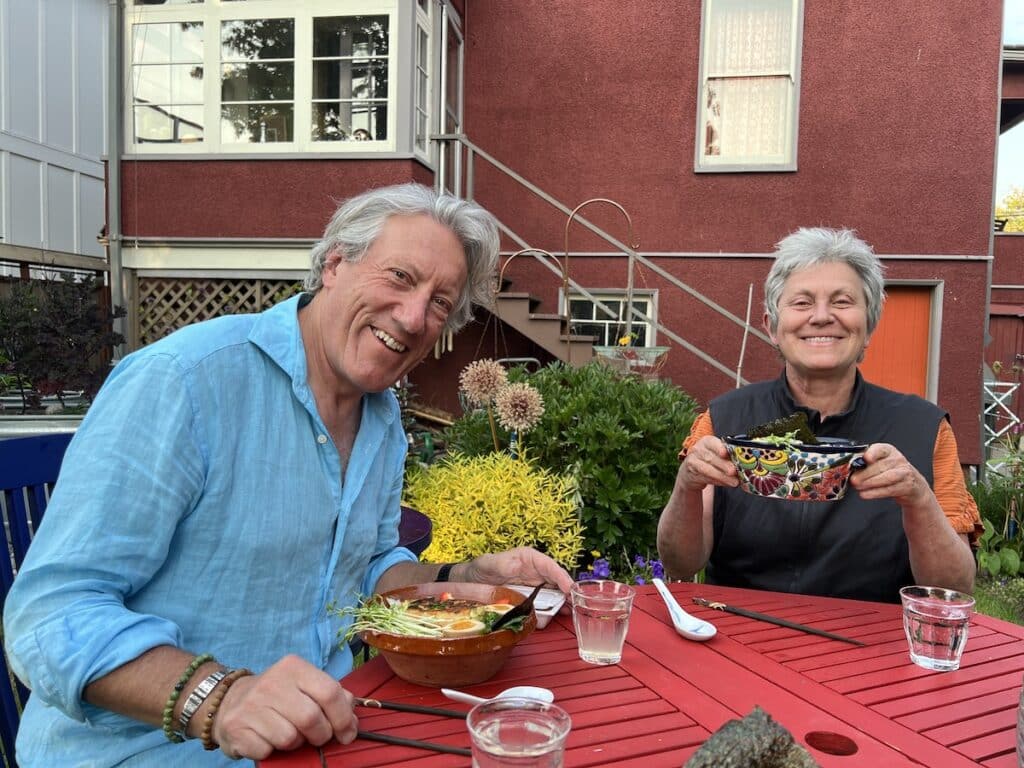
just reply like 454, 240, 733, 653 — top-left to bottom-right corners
725, 435, 867, 502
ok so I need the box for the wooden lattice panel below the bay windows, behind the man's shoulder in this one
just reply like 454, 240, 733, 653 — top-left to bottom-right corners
137, 278, 302, 346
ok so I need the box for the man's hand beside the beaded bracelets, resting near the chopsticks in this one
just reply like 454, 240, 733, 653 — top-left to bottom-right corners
209, 655, 358, 760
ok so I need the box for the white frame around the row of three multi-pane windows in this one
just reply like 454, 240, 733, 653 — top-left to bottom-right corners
123, 0, 401, 156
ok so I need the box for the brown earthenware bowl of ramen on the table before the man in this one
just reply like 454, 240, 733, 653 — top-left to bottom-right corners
359, 582, 537, 688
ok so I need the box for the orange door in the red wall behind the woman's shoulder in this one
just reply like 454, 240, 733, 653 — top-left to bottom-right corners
860, 286, 932, 397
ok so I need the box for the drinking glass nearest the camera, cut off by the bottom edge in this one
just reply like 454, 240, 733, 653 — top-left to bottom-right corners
466, 697, 572, 768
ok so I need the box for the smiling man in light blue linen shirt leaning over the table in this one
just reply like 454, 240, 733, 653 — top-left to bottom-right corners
4, 184, 571, 768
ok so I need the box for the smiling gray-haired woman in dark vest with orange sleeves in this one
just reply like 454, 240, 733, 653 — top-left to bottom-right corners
657, 227, 982, 602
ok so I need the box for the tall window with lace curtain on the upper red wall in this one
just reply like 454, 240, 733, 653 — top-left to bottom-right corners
695, 0, 803, 171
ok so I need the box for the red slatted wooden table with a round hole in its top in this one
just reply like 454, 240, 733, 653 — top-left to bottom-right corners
260, 583, 1024, 768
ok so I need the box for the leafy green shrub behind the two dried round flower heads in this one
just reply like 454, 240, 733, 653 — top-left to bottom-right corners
445, 362, 696, 553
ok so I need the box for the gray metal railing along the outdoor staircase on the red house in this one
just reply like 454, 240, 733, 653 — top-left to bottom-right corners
432, 133, 771, 386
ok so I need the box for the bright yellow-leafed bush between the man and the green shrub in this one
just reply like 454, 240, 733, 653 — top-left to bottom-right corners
403, 454, 583, 571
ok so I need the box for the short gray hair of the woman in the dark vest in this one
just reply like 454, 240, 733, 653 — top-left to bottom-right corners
765, 226, 886, 335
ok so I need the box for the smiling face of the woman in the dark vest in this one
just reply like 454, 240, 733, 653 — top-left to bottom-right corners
765, 262, 868, 378
